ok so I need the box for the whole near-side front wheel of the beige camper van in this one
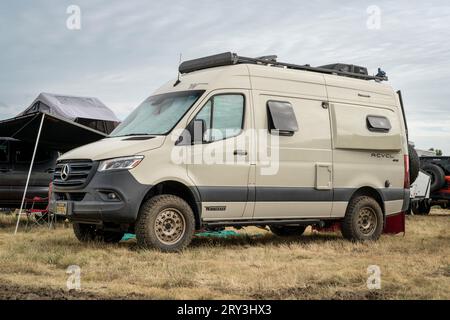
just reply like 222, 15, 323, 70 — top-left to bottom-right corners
136, 195, 195, 252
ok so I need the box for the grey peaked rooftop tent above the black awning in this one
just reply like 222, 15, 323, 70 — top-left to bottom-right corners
19, 92, 120, 134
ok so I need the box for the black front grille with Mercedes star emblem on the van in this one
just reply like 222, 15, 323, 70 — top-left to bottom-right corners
53, 160, 94, 187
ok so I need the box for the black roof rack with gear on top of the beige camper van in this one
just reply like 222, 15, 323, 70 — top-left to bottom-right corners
178, 52, 388, 81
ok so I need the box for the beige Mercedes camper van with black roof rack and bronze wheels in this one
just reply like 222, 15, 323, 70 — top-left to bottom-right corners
52, 52, 409, 251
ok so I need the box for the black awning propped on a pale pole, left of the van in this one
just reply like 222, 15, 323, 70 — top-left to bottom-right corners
0, 112, 106, 152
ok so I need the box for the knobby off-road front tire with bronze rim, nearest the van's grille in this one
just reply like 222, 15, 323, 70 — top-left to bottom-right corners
136, 195, 195, 252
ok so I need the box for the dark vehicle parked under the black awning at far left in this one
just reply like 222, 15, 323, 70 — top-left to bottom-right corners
0, 138, 59, 208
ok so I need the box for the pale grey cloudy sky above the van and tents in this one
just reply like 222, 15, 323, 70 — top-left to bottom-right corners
0, 0, 450, 155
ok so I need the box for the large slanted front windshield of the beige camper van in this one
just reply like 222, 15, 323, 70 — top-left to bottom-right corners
110, 90, 204, 137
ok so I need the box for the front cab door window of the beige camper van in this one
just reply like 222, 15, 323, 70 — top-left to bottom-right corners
195, 94, 244, 142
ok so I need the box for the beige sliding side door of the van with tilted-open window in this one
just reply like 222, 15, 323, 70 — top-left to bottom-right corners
254, 93, 333, 219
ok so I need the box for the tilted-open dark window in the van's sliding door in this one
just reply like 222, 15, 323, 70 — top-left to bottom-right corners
267, 100, 298, 136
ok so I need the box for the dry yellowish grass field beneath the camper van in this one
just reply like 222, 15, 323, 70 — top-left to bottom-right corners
0, 209, 450, 299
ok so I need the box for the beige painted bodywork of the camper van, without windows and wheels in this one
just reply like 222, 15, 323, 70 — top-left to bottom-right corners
53, 64, 408, 222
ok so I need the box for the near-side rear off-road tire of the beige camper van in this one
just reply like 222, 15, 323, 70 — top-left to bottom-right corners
341, 196, 384, 241
